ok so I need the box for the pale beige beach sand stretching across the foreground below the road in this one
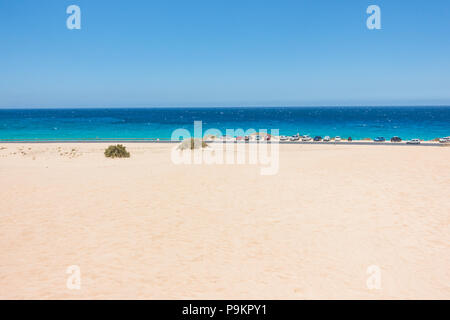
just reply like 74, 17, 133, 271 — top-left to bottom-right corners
0, 143, 450, 299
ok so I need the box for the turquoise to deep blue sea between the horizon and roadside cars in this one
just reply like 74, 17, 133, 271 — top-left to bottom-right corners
0, 107, 450, 140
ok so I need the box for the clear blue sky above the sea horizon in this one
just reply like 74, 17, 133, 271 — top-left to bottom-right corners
0, 0, 450, 107
